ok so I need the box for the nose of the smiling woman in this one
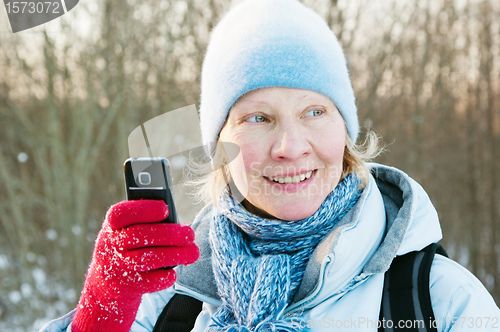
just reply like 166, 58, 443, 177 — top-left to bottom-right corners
271, 124, 312, 161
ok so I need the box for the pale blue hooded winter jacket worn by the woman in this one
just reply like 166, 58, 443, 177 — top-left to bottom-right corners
40, 164, 500, 332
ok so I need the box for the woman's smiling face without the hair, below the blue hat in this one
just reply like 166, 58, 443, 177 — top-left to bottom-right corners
220, 87, 346, 220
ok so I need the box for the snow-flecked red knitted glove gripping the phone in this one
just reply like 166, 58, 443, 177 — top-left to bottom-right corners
71, 200, 199, 332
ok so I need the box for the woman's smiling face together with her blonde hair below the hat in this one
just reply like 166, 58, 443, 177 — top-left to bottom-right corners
193, 87, 383, 220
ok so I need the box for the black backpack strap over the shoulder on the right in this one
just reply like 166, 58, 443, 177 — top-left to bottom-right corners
378, 243, 448, 332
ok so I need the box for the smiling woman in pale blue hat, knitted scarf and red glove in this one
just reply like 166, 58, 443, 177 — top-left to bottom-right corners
42, 0, 500, 332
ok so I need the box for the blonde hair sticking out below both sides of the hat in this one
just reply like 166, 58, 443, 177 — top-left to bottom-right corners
185, 130, 385, 206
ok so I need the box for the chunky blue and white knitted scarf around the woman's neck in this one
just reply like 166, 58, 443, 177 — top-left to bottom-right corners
209, 174, 361, 332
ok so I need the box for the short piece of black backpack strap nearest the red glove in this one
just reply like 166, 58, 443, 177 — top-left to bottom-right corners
153, 293, 203, 332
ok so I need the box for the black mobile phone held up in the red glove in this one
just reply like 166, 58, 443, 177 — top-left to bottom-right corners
123, 158, 178, 223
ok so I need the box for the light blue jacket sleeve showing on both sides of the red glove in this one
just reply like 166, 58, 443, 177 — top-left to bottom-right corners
40, 287, 178, 332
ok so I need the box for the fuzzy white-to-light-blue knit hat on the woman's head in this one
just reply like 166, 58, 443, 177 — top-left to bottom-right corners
200, 0, 359, 156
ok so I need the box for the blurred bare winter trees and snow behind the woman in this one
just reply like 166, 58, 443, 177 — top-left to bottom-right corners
0, 0, 500, 332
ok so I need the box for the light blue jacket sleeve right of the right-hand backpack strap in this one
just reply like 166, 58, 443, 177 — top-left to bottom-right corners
429, 255, 500, 332
